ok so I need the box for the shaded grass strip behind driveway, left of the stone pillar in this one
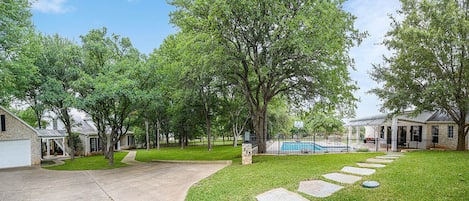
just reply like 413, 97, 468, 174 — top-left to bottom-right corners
135, 145, 241, 162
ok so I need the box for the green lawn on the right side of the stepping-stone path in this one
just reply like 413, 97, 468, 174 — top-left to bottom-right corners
324, 151, 469, 200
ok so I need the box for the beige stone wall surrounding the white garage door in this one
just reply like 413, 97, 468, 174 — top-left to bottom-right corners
0, 107, 41, 165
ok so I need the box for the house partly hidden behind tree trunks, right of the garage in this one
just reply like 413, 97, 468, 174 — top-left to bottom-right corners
45, 109, 135, 156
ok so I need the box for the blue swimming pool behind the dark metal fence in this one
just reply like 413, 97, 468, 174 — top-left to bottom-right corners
280, 142, 350, 152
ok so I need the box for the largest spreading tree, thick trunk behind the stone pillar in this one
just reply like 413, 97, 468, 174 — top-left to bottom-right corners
170, 0, 364, 153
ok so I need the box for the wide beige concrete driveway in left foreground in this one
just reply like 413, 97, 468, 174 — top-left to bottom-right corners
0, 162, 227, 201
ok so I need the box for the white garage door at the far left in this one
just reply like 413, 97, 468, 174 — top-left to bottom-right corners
0, 140, 31, 168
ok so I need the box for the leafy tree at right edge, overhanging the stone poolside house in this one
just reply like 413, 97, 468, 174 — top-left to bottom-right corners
371, 0, 469, 150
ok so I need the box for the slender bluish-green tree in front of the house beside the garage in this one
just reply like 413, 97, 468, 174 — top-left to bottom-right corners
37, 35, 82, 160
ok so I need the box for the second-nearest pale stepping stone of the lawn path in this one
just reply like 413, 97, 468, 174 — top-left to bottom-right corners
298, 180, 344, 198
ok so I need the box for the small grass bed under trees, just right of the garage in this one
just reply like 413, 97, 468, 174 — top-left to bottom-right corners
45, 152, 127, 170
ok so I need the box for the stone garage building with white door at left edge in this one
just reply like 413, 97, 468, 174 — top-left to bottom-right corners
0, 106, 41, 168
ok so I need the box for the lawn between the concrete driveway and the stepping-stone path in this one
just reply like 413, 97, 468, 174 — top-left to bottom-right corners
186, 153, 382, 201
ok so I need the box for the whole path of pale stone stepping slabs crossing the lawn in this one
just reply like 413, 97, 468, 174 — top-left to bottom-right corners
256, 153, 404, 201
